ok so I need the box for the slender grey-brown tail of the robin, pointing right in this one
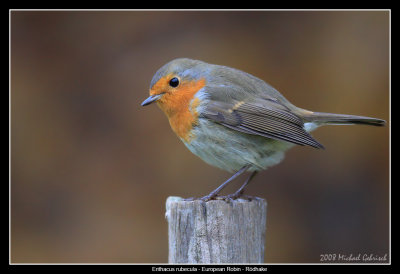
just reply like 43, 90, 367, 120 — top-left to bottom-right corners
302, 111, 386, 126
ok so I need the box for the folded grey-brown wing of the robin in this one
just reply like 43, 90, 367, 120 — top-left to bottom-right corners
200, 100, 323, 148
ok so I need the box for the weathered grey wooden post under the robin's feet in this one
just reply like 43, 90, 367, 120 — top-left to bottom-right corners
166, 197, 267, 263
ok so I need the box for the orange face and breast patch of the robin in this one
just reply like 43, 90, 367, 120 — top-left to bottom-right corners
153, 76, 206, 142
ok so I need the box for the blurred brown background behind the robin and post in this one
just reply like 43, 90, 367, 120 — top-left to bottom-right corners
11, 11, 390, 263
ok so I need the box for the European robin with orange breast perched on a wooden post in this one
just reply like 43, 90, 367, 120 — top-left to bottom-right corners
142, 58, 385, 201
